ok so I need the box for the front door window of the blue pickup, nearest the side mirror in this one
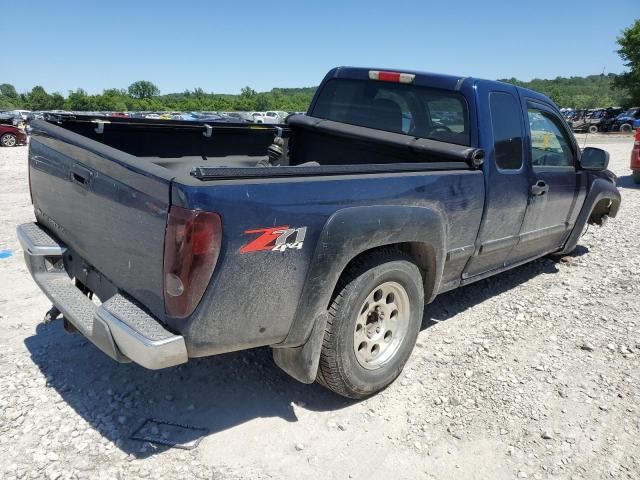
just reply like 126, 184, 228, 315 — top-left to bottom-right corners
527, 106, 575, 168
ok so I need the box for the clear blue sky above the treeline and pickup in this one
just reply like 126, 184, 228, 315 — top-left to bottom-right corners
7, 0, 640, 94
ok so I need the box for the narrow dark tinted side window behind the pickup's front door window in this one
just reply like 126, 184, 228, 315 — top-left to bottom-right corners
489, 92, 522, 170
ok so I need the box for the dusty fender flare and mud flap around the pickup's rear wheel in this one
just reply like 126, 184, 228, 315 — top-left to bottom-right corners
273, 205, 447, 383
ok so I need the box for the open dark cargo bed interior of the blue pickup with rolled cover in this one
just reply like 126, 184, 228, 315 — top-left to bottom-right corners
34, 115, 482, 181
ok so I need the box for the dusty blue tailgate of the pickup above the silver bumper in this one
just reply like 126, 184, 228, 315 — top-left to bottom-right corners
29, 121, 171, 318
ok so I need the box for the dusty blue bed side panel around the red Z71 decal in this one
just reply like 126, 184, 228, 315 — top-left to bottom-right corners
171, 170, 484, 356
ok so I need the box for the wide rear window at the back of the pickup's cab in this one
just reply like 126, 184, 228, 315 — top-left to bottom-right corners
311, 79, 469, 145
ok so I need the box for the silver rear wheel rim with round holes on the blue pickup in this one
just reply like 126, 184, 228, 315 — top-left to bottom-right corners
353, 282, 411, 370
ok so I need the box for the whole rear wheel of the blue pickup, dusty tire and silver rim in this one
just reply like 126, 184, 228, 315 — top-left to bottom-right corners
317, 249, 424, 399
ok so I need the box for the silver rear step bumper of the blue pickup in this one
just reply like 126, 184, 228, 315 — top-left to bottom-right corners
17, 223, 188, 370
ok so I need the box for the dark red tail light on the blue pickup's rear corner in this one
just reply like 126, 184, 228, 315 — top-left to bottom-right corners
164, 206, 222, 318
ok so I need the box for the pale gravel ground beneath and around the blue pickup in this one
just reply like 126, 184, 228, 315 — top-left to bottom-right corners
0, 135, 640, 480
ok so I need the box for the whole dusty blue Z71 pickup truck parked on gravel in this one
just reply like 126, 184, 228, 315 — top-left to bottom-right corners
18, 67, 620, 398
